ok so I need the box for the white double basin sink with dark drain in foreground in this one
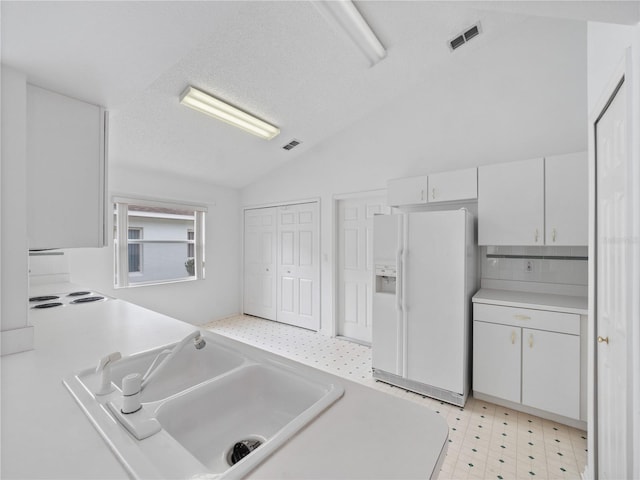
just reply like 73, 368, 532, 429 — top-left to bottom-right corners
64, 334, 344, 479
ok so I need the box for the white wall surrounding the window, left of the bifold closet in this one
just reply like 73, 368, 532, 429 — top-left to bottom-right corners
65, 165, 241, 325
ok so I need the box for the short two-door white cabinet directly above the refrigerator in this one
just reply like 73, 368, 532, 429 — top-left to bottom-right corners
387, 167, 478, 207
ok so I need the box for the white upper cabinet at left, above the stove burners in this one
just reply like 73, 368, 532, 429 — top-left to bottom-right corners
27, 85, 106, 250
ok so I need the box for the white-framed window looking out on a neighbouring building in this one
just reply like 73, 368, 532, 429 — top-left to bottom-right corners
114, 198, 206, 288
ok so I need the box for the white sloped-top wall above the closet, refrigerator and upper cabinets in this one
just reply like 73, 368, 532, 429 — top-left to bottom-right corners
242, 22, 587, 334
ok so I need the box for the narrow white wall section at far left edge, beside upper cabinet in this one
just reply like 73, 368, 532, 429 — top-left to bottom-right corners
0, 66, 33, 354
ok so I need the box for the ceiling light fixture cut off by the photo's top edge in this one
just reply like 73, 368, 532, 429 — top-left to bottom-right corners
313, 0, 387, 66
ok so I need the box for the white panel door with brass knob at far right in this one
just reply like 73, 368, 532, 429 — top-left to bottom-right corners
594, 74, 638, 478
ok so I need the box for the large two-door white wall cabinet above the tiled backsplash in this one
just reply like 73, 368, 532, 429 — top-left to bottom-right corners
478, 152, 588, 246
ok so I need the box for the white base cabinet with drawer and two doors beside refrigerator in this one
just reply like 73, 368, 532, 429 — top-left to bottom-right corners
473, 303, 581, 420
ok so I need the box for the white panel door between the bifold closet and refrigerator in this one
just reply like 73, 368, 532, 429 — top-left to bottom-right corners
337, 197, 386, 343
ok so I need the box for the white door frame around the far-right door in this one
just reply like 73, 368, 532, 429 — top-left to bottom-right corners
587, 48, 640, 479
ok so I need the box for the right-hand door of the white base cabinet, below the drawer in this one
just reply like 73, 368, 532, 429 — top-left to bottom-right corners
522, 328, 580, 419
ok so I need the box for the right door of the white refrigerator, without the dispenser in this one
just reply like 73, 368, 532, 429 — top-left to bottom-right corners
403, 210, 468, 394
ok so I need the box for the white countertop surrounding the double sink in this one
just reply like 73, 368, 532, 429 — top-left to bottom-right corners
0, 290, 448, 479
